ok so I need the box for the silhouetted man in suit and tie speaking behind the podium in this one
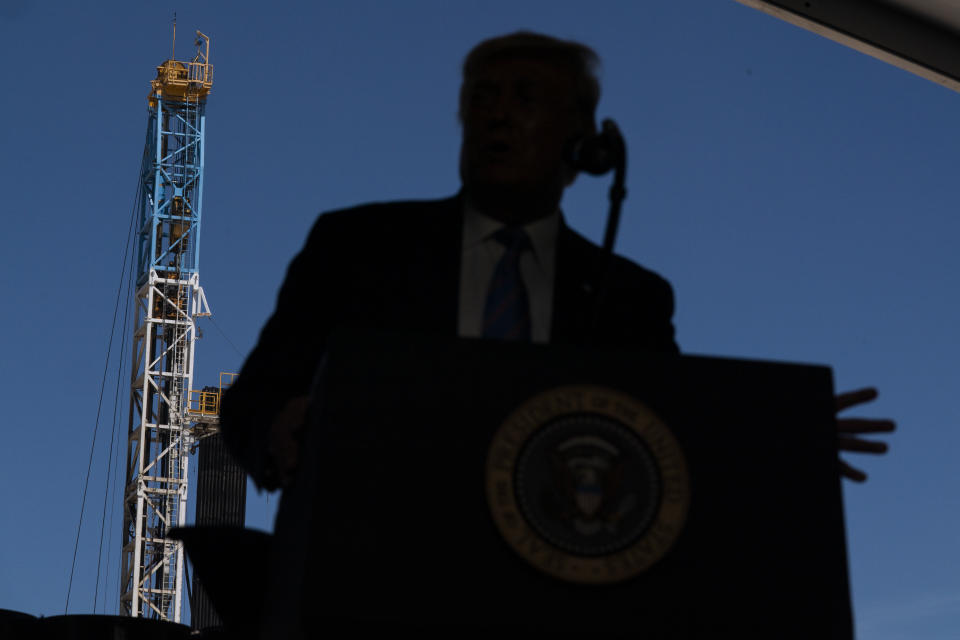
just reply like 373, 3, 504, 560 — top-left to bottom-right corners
222, 32, 893, 490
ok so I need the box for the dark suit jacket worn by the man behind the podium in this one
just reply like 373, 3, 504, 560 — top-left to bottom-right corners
221, 195, 677, 488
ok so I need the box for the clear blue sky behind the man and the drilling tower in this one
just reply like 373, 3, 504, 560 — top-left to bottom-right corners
0, 0, 960, 639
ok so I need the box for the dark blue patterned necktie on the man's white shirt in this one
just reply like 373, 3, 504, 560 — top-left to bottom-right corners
483, 227, 531, 341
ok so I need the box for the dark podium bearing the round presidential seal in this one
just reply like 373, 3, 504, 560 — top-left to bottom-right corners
266, 333, 852, 638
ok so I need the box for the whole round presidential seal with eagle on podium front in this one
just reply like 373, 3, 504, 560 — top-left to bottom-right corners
486, 386, 690, 584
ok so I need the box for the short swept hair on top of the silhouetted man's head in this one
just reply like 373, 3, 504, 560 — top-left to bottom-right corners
459, 31, 600, 129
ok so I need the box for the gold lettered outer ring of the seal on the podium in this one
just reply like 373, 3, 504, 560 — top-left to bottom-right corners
486, 385, 690, 584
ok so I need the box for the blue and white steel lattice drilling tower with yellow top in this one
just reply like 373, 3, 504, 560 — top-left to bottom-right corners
120, 31, 213, 622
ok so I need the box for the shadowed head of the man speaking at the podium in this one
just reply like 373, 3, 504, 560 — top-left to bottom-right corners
460, 32, 600, 225
